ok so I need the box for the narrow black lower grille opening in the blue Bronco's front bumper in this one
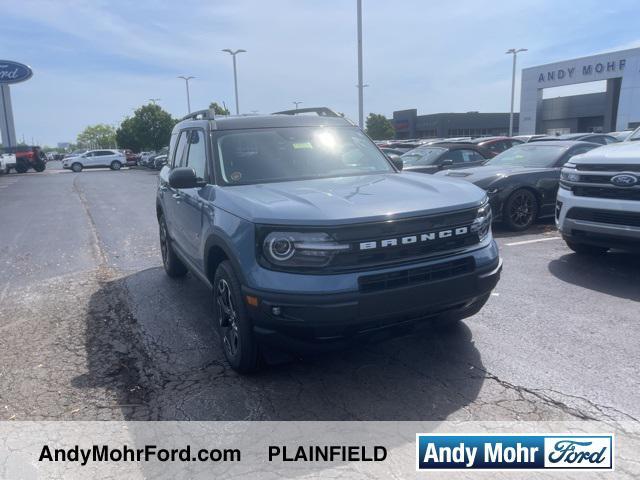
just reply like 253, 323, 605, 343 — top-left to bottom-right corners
358, 257, 475, 293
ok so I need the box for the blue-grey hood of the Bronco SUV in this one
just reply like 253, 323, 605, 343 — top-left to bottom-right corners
215, 172, 486, 225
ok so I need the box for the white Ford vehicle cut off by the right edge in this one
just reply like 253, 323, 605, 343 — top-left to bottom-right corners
556, 142, 640, 254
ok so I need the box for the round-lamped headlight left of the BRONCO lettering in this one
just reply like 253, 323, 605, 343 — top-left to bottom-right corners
262, 232, 350, 267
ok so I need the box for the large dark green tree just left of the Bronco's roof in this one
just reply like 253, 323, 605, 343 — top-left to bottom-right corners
116, 104, 178, 152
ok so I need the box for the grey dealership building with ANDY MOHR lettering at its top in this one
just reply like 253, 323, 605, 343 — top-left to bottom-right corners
519, 48, 640, 134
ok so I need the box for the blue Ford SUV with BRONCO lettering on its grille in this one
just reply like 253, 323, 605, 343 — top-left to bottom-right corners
156, 108, 502, 372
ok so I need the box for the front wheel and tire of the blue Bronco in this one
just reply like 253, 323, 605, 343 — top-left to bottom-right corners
213, 260, 259, 373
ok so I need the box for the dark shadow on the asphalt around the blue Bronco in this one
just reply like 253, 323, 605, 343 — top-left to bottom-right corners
74, 268, 485, 421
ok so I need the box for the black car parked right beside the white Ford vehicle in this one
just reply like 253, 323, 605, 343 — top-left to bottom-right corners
442, 141, 600, 231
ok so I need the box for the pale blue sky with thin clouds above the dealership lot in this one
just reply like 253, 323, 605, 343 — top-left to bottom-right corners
0, 0, 640, 146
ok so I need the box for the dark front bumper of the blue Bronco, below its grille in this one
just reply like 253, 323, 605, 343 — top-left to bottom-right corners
243, 249, 502, 351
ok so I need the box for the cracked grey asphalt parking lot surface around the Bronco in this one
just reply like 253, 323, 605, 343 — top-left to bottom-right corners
0, 162, 640, 421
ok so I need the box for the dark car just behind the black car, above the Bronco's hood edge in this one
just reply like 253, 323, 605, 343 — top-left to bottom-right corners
400, 143, 489, 173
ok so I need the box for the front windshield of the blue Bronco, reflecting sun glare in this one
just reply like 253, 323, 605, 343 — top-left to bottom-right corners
215, 127, 395, 185
